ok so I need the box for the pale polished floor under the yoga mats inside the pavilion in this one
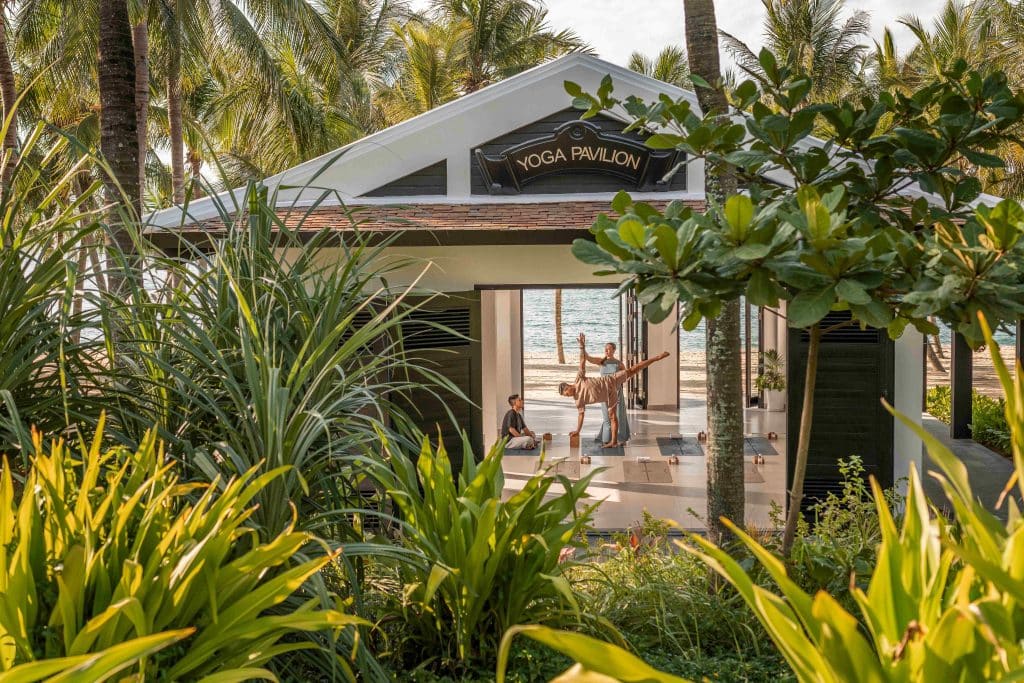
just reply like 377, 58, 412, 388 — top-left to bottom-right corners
504, 397, 785, 530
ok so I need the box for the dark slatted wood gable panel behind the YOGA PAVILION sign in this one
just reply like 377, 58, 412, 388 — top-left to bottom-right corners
467, 109, 686, 195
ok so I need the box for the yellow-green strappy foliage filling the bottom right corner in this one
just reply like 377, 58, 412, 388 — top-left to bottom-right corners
499, 323, 1024, 682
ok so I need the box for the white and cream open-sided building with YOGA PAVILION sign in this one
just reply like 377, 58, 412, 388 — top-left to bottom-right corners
150, 54, 937, 528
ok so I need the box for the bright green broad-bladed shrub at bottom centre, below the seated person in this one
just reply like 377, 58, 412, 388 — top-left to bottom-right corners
367, 439, 598, 666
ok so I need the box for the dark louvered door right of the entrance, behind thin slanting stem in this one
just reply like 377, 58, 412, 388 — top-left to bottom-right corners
785, 311, 894, 509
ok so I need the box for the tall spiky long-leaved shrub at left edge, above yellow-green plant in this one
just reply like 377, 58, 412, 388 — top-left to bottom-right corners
0, 122, 100, 454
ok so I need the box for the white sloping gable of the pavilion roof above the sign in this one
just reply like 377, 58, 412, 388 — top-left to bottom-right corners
150, 52, 696, 227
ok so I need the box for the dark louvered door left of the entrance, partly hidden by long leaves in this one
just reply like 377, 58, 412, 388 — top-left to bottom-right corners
402, 292, 483, 469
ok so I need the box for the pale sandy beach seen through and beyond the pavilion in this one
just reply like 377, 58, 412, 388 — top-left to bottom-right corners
523, 345, 1014, 399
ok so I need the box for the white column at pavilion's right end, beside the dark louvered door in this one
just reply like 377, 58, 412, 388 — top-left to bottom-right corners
890, 328, 925, 494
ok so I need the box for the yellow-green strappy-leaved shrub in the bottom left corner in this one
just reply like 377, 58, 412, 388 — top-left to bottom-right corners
0, 421, 359, 680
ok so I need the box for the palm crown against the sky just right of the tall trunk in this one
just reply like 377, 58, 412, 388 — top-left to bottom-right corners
722, 0, 870, 101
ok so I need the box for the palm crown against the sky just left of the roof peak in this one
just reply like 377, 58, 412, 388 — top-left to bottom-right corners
425, 0, 585, 92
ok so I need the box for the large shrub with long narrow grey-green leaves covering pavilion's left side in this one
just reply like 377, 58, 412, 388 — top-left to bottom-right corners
96, 184, 462, 541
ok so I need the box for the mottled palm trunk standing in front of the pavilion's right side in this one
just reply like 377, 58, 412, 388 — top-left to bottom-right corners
683, 0, 745, 543
